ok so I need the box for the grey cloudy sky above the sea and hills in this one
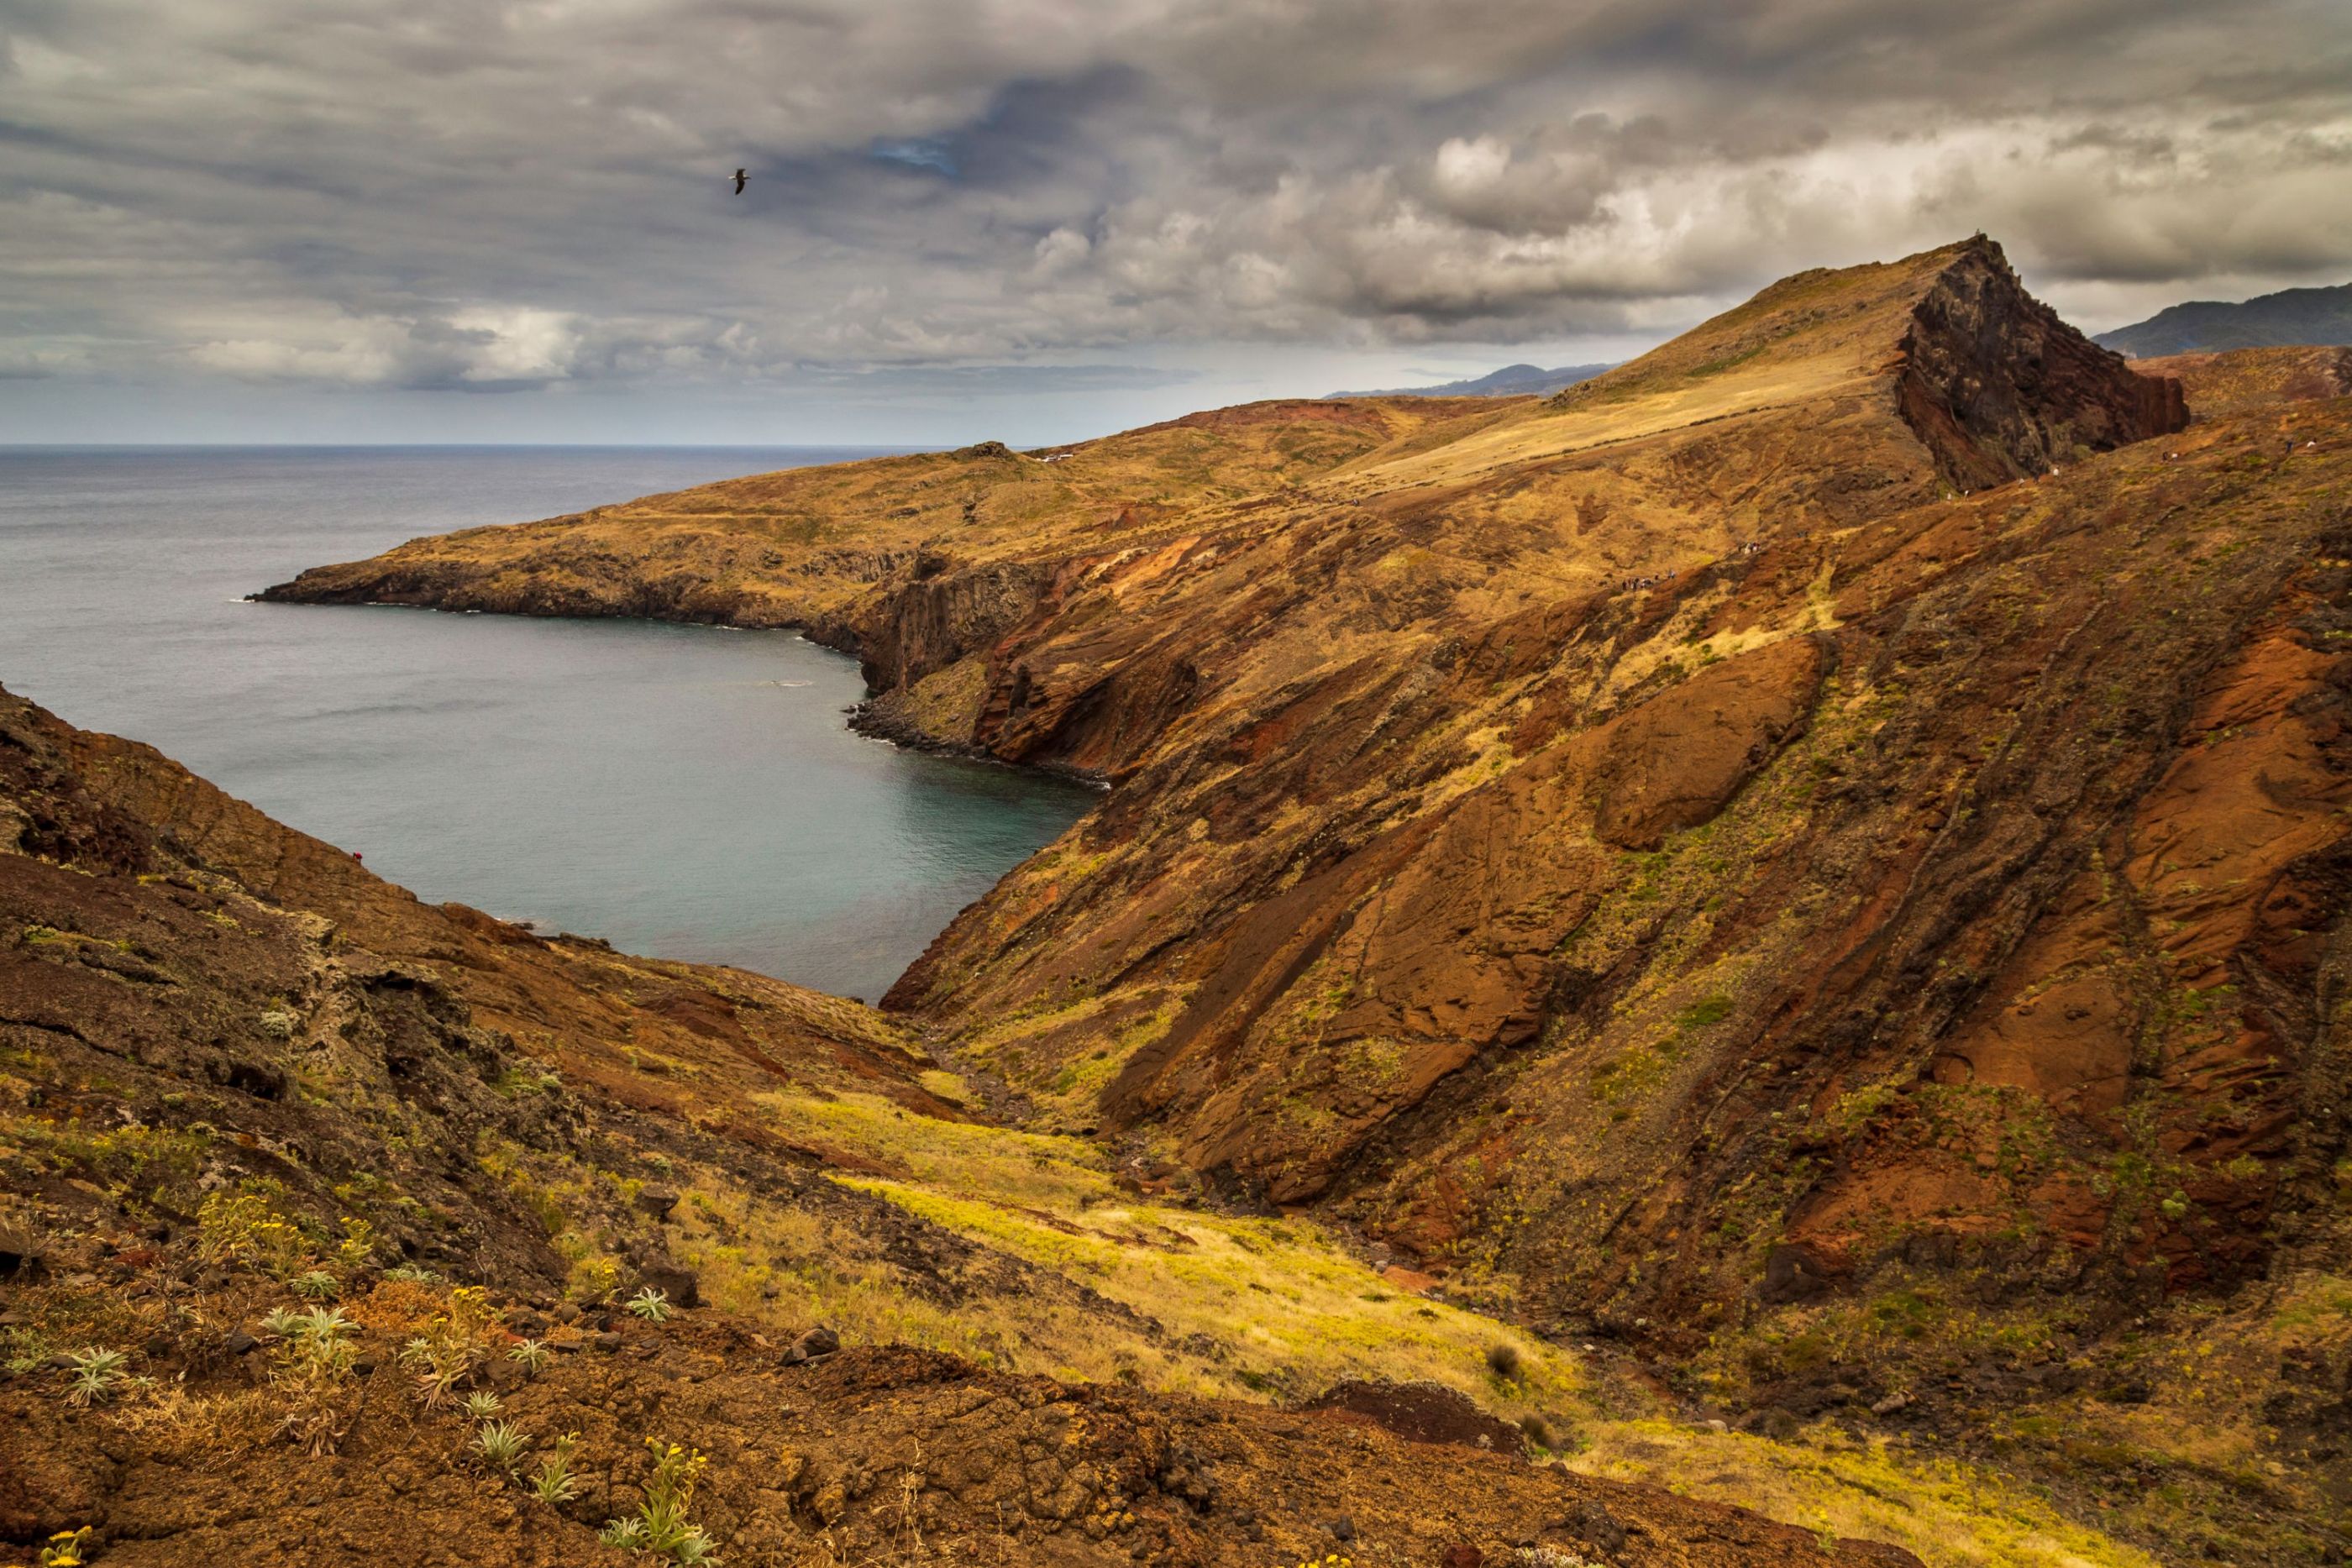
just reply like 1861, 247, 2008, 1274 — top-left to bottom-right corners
0, 0, 2352, 444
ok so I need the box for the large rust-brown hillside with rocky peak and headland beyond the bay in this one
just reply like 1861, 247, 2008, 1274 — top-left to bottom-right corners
221, 240, 2352, 1561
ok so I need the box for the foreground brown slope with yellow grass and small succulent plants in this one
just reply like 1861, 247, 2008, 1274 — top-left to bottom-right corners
0, 677, 2143, 1568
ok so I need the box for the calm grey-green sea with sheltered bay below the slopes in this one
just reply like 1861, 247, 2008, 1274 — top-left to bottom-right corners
0, 447, 1094, 999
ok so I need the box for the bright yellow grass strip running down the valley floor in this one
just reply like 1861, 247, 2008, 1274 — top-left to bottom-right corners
654, 1093, 2154, 1568
